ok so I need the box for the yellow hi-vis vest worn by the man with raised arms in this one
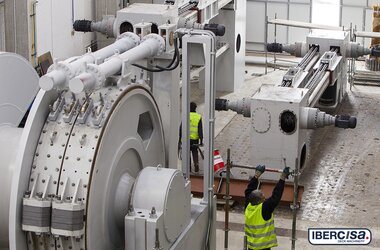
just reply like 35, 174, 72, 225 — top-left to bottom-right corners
245, 203, 277, 249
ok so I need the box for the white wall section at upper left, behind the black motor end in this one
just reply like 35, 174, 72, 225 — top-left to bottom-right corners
36, 0, 94, 59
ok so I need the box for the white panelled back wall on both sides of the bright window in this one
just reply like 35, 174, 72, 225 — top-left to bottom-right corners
247, 0, 380, 50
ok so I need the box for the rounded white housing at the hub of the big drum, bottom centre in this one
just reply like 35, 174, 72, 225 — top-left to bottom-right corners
125, 167, 191, 249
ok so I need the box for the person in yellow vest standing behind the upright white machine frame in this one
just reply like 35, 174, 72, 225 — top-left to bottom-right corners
178, 102, 203, 173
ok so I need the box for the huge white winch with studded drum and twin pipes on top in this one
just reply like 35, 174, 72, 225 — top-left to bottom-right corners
0, 5, 223, 247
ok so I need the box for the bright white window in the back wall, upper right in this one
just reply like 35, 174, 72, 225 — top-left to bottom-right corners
312, 0, 340, 26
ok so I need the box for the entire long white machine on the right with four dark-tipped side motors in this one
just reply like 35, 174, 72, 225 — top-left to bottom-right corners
216, 30, 366, 180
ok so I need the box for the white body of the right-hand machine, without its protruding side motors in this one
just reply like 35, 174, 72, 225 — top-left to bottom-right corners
251, 30, 349, 180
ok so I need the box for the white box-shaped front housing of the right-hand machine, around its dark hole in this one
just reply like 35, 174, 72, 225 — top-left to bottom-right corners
250, 84, 309, 180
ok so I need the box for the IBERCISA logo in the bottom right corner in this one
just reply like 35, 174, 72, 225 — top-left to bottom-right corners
308, 228, 372, 245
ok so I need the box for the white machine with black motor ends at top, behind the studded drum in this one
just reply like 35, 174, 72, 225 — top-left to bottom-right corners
74, 0, 246, 92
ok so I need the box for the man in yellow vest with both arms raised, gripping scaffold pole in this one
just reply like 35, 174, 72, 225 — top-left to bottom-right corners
244, 165, 290, 250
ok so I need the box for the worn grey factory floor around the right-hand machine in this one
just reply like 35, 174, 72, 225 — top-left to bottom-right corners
192, 61, 380, 250
